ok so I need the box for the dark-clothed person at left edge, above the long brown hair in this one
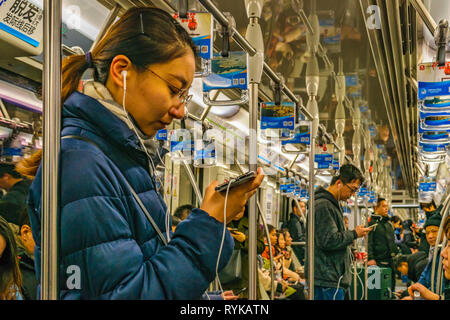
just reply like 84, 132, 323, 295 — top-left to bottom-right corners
0, 163, 31, 225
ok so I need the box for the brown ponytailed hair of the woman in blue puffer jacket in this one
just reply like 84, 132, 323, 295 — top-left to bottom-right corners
23, 7, 196, 177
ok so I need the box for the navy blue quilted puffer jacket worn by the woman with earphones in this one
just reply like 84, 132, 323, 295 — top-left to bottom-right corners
28, 92, 234, 299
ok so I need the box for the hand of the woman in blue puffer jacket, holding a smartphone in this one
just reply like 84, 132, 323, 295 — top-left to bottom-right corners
200, 168, 264, 223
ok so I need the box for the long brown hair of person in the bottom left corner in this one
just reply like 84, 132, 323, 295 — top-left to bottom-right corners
0, 217, 22, 300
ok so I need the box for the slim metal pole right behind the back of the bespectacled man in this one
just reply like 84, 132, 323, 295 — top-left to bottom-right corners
307, 135, 316, 300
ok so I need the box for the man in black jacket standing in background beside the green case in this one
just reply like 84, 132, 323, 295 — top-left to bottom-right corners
367, 198, 399, 292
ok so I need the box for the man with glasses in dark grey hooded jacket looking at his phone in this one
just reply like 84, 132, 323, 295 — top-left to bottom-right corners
305, 164, 372, 300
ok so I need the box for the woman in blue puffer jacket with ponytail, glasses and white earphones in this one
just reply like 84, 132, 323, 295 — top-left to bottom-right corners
22, 8, 264, 299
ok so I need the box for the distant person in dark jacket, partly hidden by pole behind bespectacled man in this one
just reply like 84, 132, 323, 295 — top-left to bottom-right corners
287, 200, 306, 265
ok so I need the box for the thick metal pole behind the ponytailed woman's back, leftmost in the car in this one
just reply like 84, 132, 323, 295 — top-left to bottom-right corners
41, 0, 62, 300
